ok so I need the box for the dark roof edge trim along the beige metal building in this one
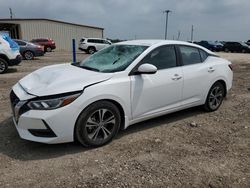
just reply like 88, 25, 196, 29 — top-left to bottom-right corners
0, 18, 104, 30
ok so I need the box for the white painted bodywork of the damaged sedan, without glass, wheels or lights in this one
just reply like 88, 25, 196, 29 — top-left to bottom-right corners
9, 40, 233, 143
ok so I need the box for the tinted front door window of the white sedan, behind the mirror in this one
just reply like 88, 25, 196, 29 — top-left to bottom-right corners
143, 46, 176, 70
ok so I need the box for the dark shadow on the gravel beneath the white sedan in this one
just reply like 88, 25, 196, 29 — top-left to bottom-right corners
0, 107, 204, 161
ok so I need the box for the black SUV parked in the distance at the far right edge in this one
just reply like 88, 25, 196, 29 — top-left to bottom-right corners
223, 42, 250, 53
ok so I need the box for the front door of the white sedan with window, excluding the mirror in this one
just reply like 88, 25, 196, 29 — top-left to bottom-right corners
131, 45, 183, 119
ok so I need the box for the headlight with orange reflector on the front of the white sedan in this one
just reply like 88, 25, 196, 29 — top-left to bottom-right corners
28, 93, 81, 110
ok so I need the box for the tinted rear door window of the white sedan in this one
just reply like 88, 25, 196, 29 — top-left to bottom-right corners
180, 46, 201, 65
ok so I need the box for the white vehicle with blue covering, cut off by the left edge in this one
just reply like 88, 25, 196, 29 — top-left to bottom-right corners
0, 34, 22, 74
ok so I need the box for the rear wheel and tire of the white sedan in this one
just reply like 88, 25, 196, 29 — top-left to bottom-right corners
203, 82, 226, 112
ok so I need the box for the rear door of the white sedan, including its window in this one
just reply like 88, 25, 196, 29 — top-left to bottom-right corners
179, 46, 212, 105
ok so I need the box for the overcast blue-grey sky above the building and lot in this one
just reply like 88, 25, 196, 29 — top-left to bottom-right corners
0, 0, 250, 41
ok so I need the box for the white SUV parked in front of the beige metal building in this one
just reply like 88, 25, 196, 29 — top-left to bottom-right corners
78, 38, 111, 54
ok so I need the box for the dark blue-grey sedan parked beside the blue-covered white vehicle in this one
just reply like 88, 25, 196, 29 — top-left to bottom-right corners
14, 39, 44, 60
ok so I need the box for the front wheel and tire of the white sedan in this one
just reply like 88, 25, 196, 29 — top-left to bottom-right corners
75, 101, 121, 147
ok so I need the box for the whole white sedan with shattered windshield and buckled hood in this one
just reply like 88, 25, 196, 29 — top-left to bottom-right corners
10, 40, 233, 147
